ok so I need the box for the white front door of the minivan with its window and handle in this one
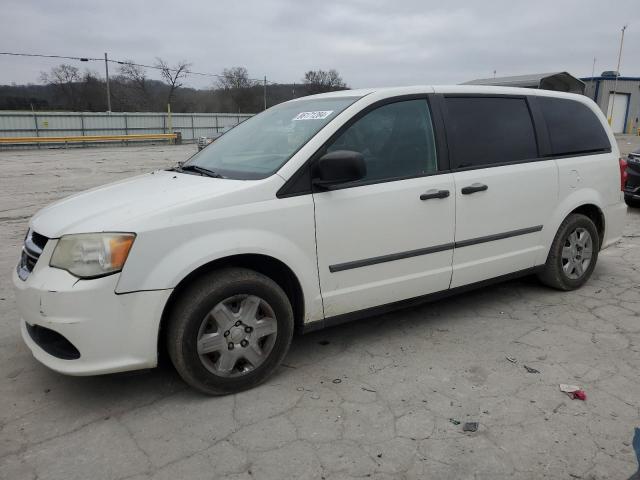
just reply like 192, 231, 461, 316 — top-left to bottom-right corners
313, 98, 455, 317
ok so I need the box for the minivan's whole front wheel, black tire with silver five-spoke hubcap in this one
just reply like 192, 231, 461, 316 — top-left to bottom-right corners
167, 268, 294, 395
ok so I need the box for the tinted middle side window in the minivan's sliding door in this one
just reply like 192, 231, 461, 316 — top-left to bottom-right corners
445, 97, 538, 168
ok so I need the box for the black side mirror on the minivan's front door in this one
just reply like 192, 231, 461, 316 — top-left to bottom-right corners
313, 150, 367, 190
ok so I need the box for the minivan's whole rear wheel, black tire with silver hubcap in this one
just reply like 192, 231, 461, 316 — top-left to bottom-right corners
538, 213, 600, 291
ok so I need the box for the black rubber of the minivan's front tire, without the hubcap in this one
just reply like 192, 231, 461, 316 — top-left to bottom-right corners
167, 268, 294, 395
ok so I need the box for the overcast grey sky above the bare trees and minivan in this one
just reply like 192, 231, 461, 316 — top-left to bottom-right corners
0, 0, 640, 88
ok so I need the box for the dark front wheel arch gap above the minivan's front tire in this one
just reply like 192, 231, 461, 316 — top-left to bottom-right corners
158, 253, 305, 356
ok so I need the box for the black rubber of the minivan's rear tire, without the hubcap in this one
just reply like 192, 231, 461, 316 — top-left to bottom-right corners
538, 213, 601, 291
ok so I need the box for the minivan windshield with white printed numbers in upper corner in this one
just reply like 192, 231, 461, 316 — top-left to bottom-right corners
184, 97, 360, 180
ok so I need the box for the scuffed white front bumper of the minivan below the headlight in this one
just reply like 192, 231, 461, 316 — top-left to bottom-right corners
13, 241, 171, 375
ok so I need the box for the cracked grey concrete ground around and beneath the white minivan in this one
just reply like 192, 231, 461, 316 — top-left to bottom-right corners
0, 137, 640, 480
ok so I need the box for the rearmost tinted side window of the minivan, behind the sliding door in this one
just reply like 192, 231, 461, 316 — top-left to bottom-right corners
538, 97, 611, 155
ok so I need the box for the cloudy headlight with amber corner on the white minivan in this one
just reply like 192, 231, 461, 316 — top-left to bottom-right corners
49, 233, 136, 278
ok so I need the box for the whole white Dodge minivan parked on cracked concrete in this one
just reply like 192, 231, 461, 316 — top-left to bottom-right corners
13, 86, 626, 394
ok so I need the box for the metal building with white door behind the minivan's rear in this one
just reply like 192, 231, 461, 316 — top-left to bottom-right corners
582, 75, 640, 133
